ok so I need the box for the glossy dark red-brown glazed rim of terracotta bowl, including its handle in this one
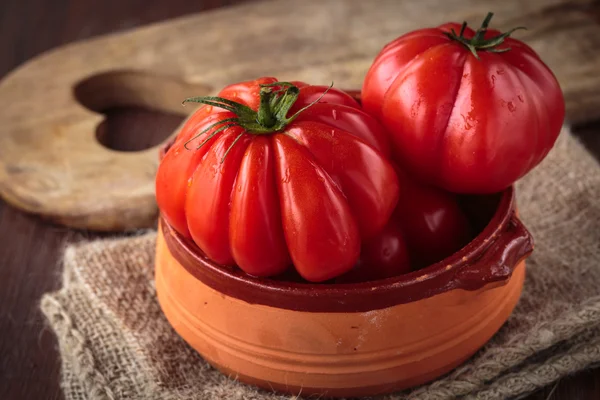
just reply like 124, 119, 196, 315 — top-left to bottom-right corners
159, 152, 533, 312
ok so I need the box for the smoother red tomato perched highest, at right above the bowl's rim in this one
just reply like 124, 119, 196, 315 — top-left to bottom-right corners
362, 14, 565, 193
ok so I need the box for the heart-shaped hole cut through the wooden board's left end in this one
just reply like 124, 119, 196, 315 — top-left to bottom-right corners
73, 70, 211, 151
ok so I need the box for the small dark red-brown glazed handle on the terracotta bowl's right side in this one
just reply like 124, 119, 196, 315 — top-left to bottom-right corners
455, 213, 534, 290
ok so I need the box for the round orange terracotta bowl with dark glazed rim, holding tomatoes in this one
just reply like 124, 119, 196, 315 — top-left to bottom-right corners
156, 175, 533, 397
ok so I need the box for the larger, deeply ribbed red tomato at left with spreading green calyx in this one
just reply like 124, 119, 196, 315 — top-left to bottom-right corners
156, 78, 399, 282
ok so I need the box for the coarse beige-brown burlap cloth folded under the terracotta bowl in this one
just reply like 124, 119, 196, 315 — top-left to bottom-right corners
41, 129, 600, 400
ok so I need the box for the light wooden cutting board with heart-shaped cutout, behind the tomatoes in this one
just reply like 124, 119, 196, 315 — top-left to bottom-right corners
0, 0, 600, 231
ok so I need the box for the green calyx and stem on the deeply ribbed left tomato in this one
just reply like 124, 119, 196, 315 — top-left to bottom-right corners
182, 82, 333, 163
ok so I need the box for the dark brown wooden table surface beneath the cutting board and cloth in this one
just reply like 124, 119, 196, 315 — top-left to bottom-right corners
0, 0, 600, 400
